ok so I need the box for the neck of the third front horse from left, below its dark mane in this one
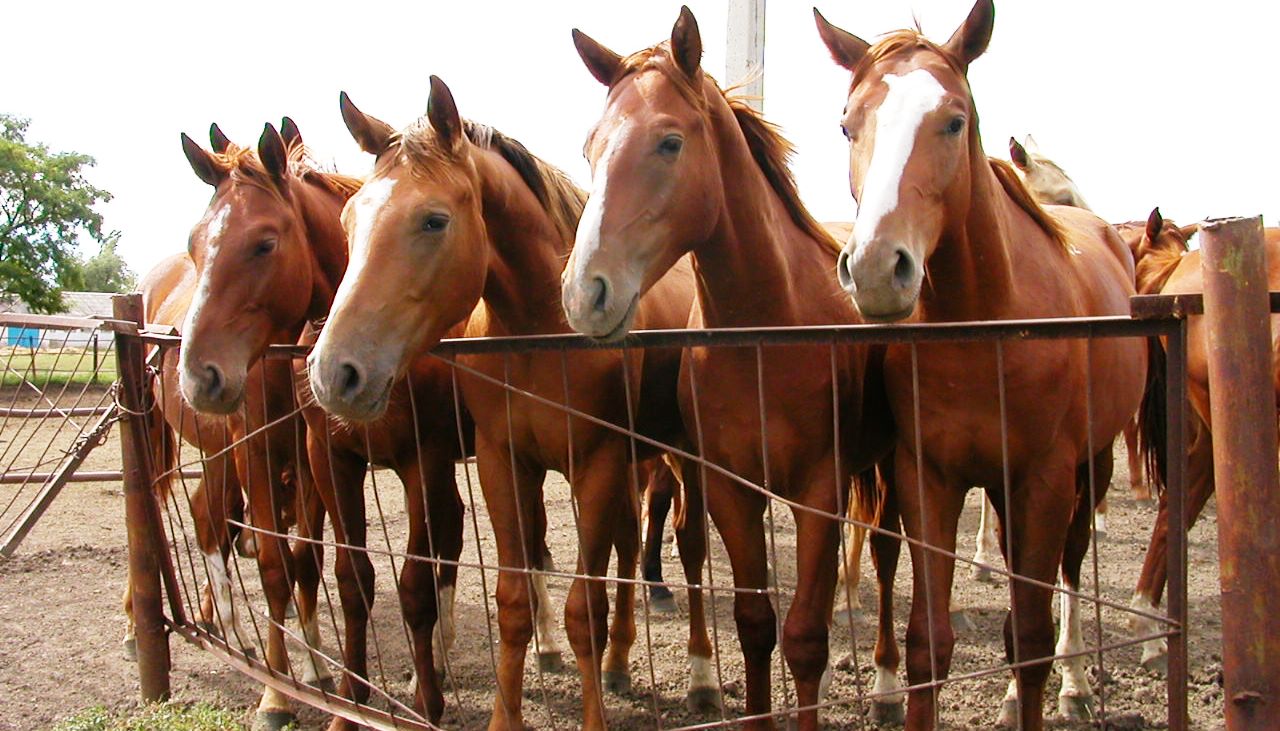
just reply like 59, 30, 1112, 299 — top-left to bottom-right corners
692, 93, 838, 328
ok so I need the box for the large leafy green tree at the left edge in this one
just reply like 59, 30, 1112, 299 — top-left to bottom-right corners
0, 114, 111, 312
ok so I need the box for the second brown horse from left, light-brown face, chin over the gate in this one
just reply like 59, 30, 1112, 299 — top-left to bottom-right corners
310, 77, 718, 730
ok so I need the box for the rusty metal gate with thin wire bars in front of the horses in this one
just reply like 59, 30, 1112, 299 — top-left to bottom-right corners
115, 289, 1208, 728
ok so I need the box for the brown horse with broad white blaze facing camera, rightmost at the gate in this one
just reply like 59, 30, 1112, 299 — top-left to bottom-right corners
818, 0, 1146, 730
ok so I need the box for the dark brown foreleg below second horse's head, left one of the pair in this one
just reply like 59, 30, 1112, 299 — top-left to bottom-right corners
307, 429, 374, 731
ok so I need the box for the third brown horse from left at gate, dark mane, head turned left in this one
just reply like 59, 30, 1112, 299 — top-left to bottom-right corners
563, 8, 896, 728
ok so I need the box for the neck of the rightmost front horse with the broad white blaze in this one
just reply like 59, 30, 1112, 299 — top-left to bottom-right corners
920, 144, 1025, 321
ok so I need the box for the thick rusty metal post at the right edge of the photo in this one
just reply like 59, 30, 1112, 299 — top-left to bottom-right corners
1201, 216, 1280, 731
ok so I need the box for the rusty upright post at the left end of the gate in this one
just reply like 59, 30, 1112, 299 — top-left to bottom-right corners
111, 294, 169, 703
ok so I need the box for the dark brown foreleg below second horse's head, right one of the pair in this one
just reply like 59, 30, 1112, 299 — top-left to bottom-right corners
397, 446, 456, 723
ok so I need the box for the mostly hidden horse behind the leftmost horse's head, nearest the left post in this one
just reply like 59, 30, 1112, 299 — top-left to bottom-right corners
141, 125, 332, 727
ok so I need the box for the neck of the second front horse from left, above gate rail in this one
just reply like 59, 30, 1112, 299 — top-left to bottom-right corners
475, 150, 576, 334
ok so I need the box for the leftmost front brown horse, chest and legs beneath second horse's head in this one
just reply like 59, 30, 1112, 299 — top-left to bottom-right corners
182, 125, 470, 728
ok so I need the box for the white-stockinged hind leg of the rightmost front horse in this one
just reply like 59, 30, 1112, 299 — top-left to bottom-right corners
1055, 453, 1114, 721
